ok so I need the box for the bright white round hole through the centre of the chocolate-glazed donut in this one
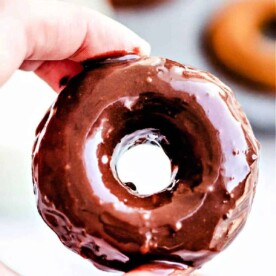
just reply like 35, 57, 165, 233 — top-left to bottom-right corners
111, 129, 178, 197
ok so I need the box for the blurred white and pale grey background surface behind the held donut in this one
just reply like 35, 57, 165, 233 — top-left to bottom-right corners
0, 0, 276, 276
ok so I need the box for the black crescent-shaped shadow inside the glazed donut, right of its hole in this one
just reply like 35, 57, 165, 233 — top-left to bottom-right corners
111, 114, 202, 194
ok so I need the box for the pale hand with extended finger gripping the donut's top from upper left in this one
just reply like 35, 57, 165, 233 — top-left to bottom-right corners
0, 0, 149, 85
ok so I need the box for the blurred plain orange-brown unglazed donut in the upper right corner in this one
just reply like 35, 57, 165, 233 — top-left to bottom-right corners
207, 0, 276, 93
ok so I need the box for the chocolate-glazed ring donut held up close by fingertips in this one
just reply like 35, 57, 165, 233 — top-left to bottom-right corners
33, 56, 259, 271
